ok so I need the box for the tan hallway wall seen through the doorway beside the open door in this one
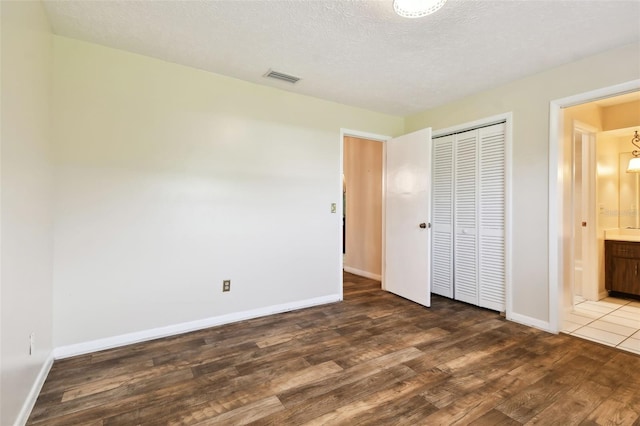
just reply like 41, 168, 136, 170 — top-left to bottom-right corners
344, 136, 383, 277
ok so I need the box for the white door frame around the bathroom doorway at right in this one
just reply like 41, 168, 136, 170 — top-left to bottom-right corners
548, 79, 640, 333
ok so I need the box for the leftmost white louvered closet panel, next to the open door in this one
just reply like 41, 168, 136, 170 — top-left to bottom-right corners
431, 135, 454, 298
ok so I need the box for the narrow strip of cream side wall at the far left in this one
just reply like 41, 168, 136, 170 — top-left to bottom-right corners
0, 1, 52, 425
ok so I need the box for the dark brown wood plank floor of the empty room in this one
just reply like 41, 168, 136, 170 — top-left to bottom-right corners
29, 274, 640, 425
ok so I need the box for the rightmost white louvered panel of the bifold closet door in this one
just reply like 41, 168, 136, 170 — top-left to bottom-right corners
478, 123, 506, 312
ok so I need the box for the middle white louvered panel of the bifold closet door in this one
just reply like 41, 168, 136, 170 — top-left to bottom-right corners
453, 130, 478, 305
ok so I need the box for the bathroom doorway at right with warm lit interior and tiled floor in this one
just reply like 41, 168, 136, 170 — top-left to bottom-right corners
549, 80, 640, 350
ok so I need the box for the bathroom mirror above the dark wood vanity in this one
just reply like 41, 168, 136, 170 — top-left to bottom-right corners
618, 152, 640, 229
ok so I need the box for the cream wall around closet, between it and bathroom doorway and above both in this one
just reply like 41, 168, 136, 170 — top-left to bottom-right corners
405, 44, 640, 325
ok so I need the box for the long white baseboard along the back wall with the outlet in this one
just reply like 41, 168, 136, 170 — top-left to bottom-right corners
53, 294, 340, 359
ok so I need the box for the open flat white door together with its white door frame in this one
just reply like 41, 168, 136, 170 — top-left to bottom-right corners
337, 128, 431, 307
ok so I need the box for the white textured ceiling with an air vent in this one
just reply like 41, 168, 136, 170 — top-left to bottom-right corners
44, 0, 640, 116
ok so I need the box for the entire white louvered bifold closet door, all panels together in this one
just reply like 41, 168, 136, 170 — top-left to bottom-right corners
431, 123, 506, 311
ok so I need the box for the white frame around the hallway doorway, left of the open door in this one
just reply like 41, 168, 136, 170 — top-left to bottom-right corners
336, 128, 391, 300
